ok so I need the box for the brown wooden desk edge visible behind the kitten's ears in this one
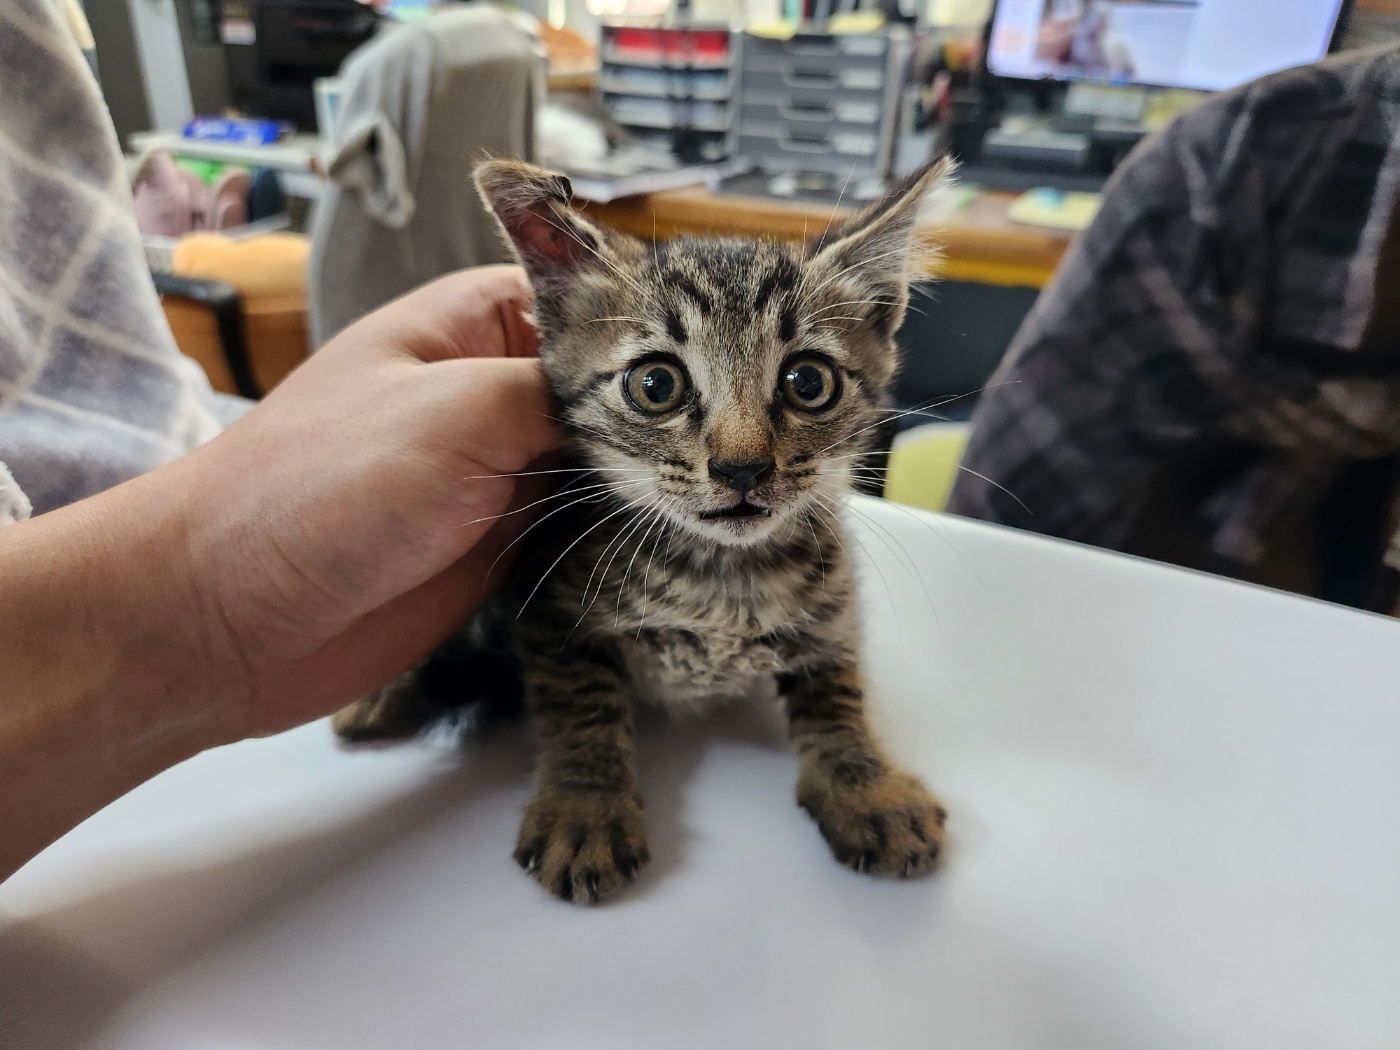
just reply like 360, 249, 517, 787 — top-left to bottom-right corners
584, 186, 1072, 288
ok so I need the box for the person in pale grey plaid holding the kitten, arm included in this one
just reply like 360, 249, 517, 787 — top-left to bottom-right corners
0, 0, 557, 879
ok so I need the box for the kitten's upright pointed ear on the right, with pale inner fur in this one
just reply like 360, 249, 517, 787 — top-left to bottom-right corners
808, 157, 956, 298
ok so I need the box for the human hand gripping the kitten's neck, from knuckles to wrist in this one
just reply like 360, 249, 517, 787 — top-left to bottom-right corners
165, 266, 557, 735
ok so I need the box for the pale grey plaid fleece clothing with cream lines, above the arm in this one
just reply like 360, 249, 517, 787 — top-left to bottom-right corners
0, 0, 246, 522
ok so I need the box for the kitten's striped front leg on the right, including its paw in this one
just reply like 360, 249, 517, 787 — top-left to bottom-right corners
778, 662, 946, 878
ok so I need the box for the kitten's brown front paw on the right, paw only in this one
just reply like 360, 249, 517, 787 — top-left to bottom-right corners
797, 773, 948, 879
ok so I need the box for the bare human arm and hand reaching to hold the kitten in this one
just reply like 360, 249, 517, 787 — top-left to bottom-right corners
0, 267, 557, 879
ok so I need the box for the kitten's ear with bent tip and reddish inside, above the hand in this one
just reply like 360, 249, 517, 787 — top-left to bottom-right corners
473, 161, 603, 291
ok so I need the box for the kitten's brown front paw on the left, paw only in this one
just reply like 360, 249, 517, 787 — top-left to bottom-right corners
515, 788, 651, 904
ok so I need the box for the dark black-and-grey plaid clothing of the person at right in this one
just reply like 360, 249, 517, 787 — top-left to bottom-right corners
949, 48, 1400, 593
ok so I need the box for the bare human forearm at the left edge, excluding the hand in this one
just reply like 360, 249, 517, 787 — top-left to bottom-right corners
0, 468, 244, 879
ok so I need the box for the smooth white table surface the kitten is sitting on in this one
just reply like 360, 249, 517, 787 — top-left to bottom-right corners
0, 503, 1400, 1050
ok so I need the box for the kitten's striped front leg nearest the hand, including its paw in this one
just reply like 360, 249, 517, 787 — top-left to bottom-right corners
515, 655, 650, 904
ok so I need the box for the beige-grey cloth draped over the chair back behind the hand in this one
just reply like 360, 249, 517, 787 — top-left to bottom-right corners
311, 4, 545, 346
